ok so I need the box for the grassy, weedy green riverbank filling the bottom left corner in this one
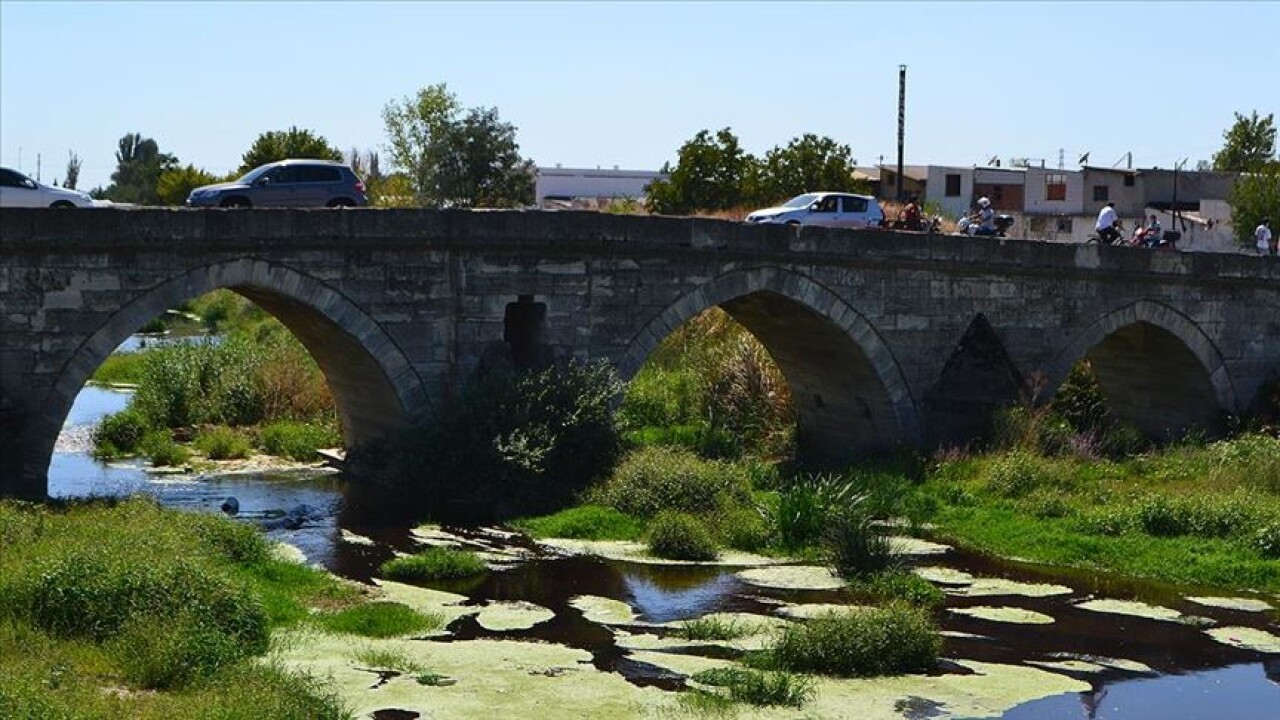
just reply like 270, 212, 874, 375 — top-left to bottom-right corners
0, 498, 357, 719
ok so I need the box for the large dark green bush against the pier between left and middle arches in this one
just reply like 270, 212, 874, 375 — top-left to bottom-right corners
363, 361, 626, 521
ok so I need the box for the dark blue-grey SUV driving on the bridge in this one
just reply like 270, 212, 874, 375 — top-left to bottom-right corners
187, 160, 369, 208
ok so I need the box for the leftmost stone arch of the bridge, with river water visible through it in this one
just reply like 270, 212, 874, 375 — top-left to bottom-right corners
26, 258, 425, 486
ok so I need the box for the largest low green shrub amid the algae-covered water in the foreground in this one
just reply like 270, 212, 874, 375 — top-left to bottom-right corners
760, 603, 942, 676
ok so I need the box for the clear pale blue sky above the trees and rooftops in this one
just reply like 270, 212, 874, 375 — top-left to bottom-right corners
0, 0, 1280, 188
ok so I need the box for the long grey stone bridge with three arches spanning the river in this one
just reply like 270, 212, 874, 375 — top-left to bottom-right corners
0, 209, 1280, 497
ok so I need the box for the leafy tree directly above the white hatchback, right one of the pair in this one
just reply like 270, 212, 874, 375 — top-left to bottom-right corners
753, 133, 869, 205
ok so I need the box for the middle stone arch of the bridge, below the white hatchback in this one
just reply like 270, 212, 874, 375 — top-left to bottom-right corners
618, 268, 922, 456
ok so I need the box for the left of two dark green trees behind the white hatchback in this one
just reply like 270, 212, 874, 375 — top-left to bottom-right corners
645, 128, 759, 215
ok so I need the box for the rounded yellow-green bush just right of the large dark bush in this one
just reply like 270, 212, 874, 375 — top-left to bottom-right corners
588, 447, 750, 518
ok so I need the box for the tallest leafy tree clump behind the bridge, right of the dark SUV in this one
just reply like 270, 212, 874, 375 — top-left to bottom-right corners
383, 83, 534, 208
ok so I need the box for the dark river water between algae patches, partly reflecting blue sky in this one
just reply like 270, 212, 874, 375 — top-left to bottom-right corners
49, 387, 1280, 720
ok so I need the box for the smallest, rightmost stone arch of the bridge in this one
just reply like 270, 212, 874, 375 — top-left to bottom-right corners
1046, 300, 1240, 436
